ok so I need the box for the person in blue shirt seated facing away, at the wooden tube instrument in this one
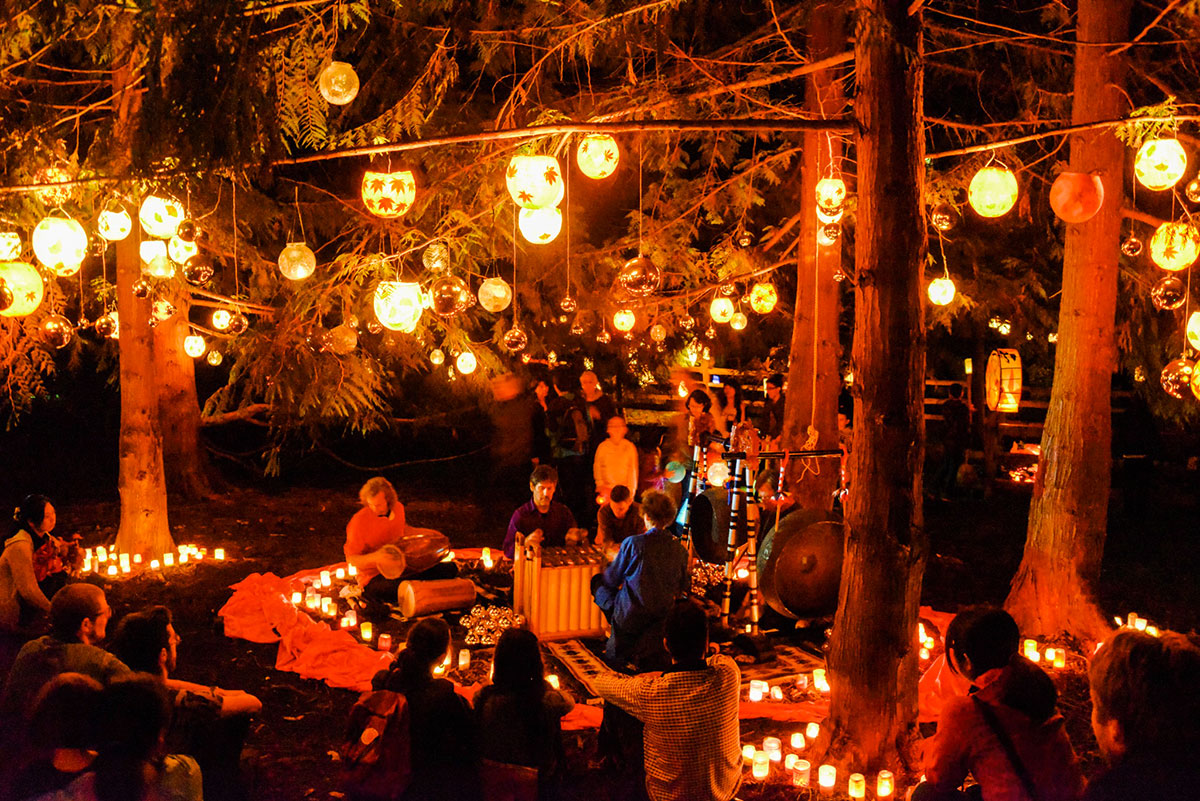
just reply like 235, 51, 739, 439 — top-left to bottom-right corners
592, 492, 691, 670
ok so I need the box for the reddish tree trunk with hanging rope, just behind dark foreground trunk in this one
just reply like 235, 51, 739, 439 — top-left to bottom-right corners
784, 1, 846, 511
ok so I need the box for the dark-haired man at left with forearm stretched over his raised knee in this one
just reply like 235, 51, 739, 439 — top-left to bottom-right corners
113, 606, 263, 799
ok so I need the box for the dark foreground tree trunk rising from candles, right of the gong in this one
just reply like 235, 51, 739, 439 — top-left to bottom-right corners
821, 0, 929, 770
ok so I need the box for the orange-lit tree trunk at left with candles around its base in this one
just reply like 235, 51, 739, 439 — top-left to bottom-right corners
112, 13, 174, 558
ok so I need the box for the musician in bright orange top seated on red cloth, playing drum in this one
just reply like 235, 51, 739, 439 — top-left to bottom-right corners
343, 476, 458, 604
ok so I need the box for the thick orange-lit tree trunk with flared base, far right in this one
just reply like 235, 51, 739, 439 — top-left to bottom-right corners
1004, 0, 1130, 642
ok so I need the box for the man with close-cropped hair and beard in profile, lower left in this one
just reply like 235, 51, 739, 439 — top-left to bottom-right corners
0, 583, 130, 717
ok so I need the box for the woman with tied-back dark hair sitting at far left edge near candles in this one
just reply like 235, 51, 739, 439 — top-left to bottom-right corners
0, 495, 79, 631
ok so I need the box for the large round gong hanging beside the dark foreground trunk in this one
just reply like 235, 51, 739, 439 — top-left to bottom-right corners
758, 510, 846, 619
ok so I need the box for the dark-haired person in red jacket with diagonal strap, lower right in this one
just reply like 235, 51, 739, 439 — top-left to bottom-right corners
912, 607, 1084, 801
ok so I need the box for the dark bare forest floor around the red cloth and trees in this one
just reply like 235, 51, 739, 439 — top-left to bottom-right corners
39, 462, 1200, 801
